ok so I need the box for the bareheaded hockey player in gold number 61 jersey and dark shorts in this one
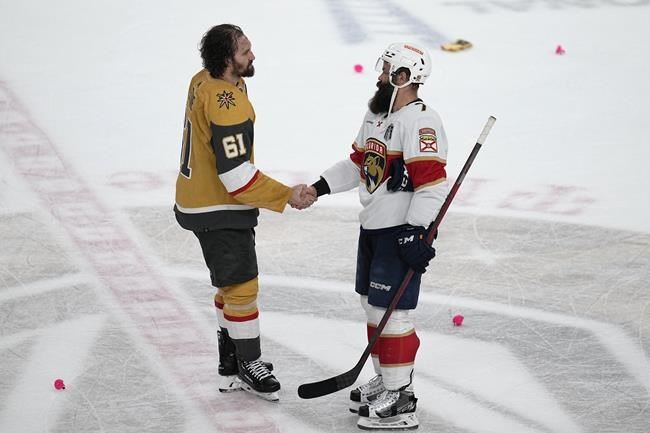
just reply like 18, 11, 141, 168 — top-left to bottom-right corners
174, 24, 316, 400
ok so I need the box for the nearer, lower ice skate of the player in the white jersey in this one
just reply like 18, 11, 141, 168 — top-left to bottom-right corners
357, 389, 419, 430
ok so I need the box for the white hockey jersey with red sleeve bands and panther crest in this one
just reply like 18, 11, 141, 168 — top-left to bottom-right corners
322, 99, 448, 229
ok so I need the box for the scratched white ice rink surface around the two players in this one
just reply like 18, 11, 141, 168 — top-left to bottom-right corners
0, 0, 650, 433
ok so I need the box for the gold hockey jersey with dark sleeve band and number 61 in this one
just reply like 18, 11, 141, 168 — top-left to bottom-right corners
174, 69, 291, 231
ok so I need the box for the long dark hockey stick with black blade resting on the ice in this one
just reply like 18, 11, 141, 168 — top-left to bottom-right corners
298, 116, 497, 398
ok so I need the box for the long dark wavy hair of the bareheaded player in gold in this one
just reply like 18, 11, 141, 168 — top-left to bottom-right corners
199, 24, 244, 78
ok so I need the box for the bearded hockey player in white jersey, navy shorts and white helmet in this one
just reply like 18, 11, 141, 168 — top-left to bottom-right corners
312, 43, 448, 429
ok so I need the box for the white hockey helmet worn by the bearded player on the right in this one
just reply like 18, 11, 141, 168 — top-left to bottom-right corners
375, 42, 431, 87
